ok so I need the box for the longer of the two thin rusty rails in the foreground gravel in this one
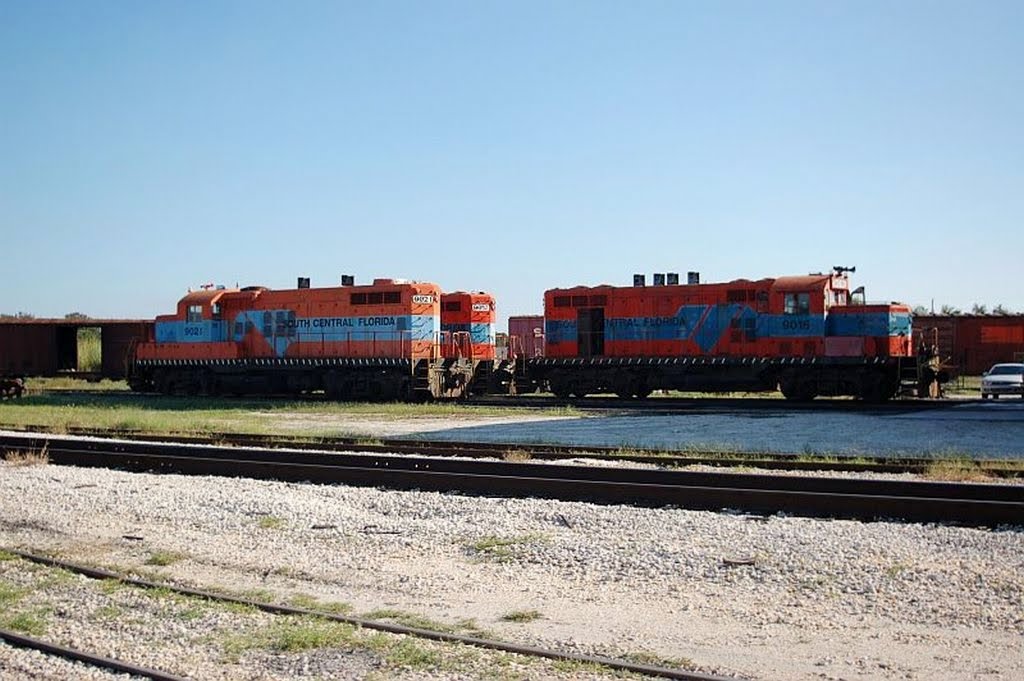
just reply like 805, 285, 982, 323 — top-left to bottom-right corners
3, 548, 741, 681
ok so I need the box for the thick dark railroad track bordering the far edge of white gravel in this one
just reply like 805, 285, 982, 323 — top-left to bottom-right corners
0, 434, 1024, 526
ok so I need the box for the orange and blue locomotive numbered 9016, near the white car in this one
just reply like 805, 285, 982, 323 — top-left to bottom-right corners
516, 267, 934, 401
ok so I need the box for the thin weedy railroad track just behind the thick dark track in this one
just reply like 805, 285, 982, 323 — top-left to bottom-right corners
9, 426, 1024, 477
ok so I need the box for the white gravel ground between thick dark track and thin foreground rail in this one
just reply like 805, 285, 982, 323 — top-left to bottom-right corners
0, 448, 1024, 679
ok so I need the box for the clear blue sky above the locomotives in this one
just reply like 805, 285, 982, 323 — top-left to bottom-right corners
0, 0, 1024, 317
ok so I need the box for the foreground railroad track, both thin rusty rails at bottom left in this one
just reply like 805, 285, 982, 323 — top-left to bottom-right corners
0, 548, 736, 681
